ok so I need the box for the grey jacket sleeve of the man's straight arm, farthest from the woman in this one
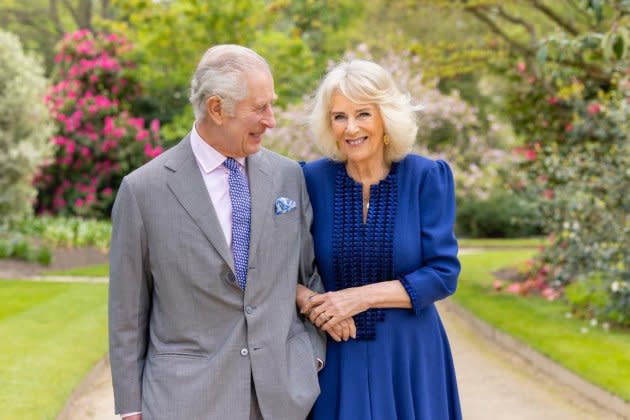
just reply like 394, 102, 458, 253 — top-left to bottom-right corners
109, 179, 152, 413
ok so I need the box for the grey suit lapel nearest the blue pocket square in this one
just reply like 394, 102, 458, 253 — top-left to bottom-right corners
247, 150, 275, 262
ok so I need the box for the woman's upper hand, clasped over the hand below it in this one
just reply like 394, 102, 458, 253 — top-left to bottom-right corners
301, 287, 369, 333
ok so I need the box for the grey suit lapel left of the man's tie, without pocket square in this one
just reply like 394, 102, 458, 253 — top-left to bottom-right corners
165, 136, 236, 271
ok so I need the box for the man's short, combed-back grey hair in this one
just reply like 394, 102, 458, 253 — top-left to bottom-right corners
190, 44, 271, 121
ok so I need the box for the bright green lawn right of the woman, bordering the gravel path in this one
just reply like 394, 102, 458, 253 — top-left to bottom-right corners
454, 250, 630, 401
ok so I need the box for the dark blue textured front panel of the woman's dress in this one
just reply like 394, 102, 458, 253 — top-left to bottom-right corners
332, 163, 397, 340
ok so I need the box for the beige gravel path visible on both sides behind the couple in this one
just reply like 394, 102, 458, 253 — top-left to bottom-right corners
58, 305, 630, 420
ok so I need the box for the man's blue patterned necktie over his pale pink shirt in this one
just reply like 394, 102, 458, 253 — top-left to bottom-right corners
223, 158, 251, 289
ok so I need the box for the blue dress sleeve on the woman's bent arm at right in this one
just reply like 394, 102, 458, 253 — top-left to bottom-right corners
399, 160, 460, 314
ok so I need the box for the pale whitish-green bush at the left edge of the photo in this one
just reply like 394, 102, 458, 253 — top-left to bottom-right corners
0, 31, 53, 222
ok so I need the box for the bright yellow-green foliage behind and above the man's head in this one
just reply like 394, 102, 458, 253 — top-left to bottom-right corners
100, 0, 362, 143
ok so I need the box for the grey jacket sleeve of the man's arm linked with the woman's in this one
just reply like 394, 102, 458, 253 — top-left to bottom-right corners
298, 170, 326, 362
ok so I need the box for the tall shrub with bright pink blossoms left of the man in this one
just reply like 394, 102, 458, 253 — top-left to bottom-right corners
35, 30, 162, 217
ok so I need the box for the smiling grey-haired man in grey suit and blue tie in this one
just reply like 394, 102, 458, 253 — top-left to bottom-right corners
109, 45, 325, 420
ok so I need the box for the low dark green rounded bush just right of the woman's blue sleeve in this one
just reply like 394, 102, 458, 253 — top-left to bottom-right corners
456, 191, 542, 238
